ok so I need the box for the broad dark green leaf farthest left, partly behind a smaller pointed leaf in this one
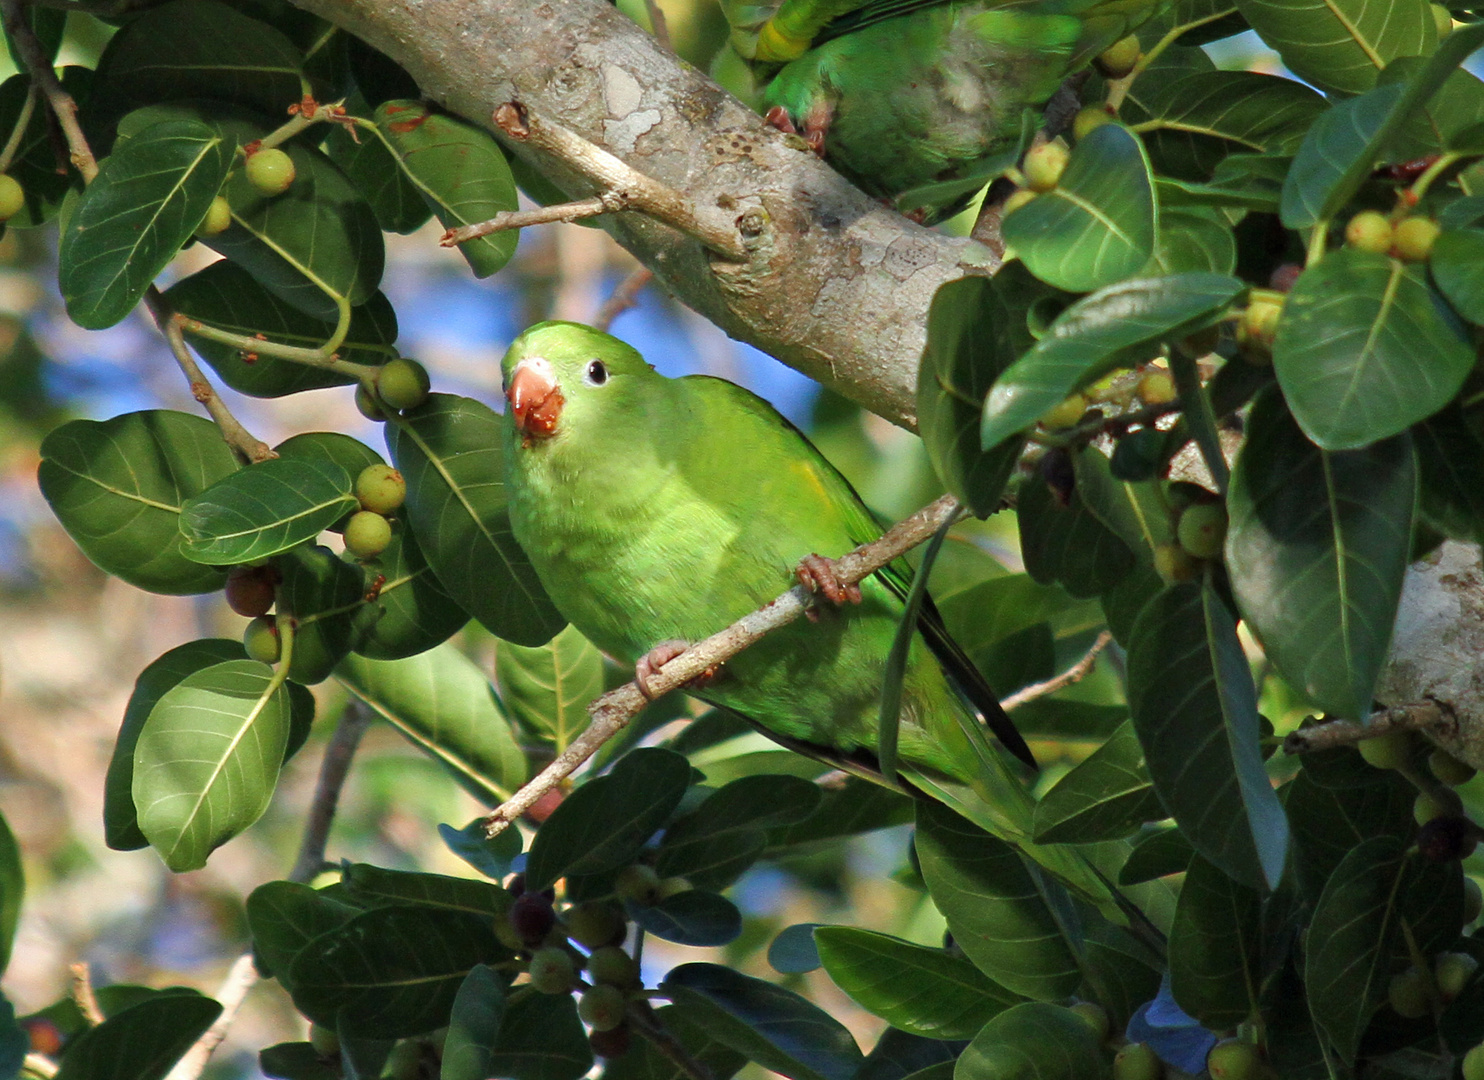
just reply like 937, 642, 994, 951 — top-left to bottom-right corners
39, 409, 237, 593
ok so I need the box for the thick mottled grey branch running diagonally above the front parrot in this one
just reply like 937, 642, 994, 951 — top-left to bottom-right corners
294, 0, 994, 427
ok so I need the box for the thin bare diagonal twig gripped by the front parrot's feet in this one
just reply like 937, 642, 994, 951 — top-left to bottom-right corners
481, 495, 965, 837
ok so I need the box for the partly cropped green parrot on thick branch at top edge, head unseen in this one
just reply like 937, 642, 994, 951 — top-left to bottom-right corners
721, 0, 1166, 224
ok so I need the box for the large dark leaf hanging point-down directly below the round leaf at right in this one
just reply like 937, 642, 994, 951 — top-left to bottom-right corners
1226, 392, 1417, 720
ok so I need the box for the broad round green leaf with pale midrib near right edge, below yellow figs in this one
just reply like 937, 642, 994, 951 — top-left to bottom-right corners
1273, 248, 1474, 450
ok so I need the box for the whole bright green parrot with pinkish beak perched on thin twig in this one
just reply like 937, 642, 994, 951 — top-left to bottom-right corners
503, 322, 1098, 893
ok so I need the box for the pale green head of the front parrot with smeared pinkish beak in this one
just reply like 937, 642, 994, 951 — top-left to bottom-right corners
502, 322, 657, 447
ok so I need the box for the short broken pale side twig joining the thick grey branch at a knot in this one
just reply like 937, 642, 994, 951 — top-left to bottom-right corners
494, 101, 748, 263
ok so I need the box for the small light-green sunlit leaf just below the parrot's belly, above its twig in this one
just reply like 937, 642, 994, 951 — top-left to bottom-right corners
494, 626, 604, 754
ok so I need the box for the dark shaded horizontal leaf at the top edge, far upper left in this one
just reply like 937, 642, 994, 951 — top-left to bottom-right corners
98, 0, 304, 116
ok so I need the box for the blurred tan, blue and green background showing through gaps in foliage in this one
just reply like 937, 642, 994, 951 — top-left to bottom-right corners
0, 0, 1400, 1076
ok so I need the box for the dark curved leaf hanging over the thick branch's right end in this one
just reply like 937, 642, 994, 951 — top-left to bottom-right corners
917, 270, 1060, 515
